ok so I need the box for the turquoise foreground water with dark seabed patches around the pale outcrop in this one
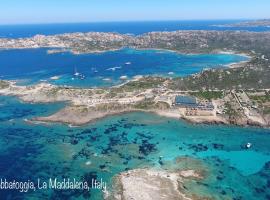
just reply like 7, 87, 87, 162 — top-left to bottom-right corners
0, 97, 270, 200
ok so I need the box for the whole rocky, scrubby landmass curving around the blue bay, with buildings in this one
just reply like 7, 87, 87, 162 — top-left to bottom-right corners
0, 31, 270, 126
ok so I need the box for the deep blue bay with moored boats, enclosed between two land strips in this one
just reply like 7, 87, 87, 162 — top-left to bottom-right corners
0, 49, 247, 87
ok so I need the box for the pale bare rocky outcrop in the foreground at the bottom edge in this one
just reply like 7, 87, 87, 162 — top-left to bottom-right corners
105, 169, 202, 200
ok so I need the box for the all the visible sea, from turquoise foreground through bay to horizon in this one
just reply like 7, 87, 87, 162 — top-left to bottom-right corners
0, 21, 270, 200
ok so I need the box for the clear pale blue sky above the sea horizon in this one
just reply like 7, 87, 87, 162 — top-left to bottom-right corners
0, 0, 270, 24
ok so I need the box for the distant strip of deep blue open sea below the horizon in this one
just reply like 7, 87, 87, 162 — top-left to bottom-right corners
0, 20, 270, 38
